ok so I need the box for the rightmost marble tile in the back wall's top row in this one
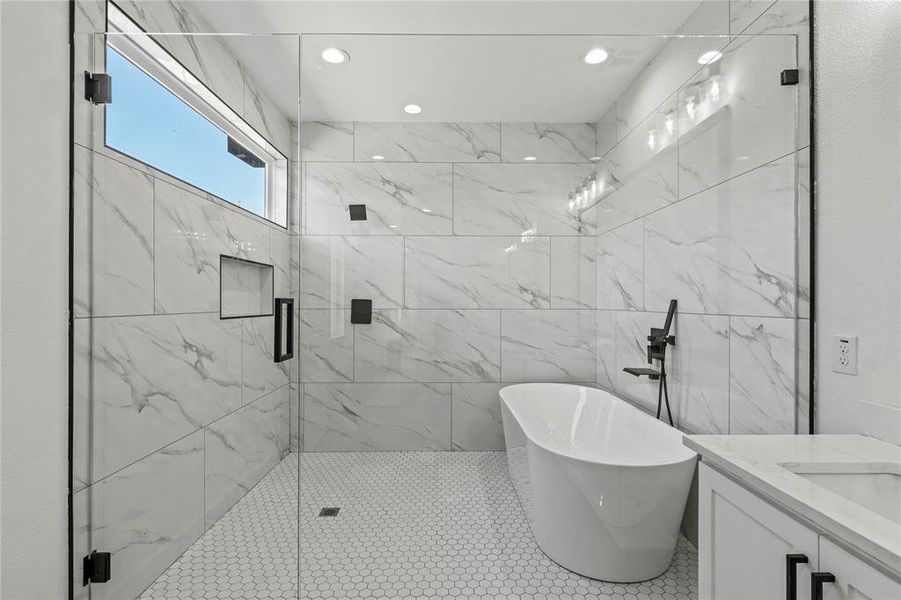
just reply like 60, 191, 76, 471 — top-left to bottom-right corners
501, 123, 598, 163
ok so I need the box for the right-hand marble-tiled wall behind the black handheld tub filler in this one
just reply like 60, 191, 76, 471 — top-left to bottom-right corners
595, 0, 810, 433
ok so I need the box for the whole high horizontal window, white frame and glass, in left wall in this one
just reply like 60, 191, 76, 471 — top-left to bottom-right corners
105, 4, 288, 227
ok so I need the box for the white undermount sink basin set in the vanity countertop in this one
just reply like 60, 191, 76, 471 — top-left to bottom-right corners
780, 463, 901, 525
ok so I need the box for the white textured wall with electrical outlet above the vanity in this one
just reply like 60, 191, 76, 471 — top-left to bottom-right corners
814, 2, 901, 443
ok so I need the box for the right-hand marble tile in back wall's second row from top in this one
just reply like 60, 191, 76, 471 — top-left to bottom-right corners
453, 164, 595, 235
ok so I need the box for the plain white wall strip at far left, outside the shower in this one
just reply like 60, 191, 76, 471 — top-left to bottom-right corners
0, 1, 69, 599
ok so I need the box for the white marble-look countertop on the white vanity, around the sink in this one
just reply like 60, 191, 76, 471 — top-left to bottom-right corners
684, 435, 901, 576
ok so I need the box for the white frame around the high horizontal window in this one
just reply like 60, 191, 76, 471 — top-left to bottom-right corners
104, 2, 288, 228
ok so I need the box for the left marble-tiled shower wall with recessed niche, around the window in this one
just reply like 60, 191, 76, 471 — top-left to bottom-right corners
73, 1, 296, 600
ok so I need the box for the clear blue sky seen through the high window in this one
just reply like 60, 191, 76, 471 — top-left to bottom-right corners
106, 46, 266, 217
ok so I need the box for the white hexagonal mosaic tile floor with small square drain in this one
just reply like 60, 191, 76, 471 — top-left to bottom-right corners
142, 452, 697, 600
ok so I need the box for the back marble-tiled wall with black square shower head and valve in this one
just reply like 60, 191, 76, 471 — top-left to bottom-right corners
292, 122, 597, 451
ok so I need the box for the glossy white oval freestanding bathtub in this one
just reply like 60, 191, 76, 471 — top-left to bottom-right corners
500, 383, 697, 582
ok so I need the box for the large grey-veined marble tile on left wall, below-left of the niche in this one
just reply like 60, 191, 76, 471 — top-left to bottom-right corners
93, 314, 241, 481
